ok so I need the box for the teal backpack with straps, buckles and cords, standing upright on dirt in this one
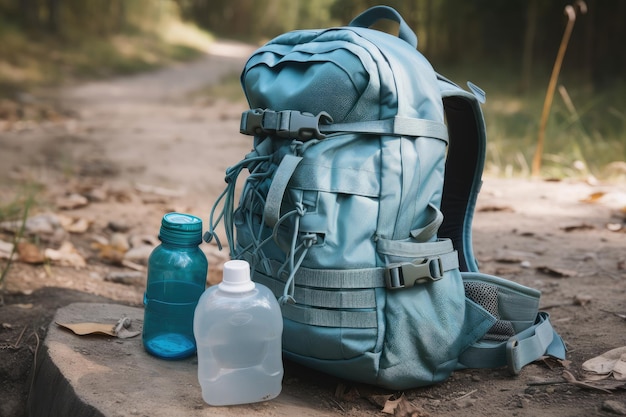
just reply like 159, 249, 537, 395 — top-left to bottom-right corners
205, 6, 565, 389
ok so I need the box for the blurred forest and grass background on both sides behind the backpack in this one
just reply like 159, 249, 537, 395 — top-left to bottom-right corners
0, 0, 626, 180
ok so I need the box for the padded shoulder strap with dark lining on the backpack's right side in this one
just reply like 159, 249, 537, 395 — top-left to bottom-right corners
437, 74, 486, 272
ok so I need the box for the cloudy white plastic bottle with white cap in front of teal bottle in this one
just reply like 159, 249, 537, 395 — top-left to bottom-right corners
193, 260, 283, 405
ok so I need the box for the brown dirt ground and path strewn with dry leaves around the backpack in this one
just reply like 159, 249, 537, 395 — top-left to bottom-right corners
0, 39, 626, 417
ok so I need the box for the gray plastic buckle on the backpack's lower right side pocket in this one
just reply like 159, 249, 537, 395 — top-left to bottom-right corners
385, 257, 444, 290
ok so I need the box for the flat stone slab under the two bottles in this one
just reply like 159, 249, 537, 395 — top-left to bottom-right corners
28, 303, 333, 417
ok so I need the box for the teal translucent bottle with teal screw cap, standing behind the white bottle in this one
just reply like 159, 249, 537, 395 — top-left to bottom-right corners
143, 213, 208, 359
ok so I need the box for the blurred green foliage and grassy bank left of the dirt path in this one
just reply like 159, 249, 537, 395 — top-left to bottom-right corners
0, 0, 211, 92
